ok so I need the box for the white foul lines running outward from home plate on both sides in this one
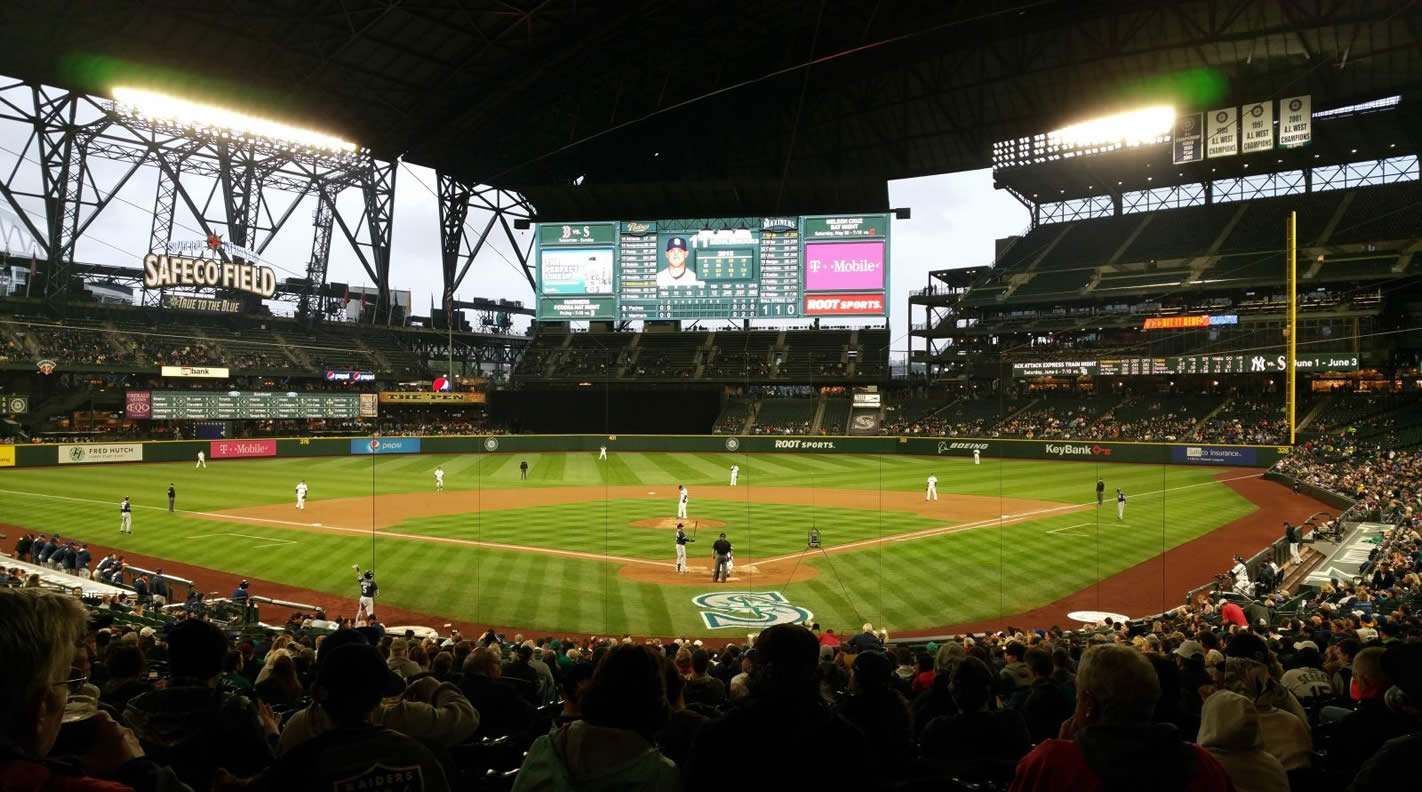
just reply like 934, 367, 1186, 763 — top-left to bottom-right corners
0, 473, 1264, 569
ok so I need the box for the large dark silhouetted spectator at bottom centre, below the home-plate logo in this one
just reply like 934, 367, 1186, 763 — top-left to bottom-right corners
685, 624, 866, 791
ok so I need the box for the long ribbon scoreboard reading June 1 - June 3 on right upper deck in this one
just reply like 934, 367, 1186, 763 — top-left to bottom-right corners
1012, 353, 1358, 378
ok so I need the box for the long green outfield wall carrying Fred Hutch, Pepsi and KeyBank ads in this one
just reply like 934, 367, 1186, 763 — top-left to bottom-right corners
0, 435, 1288, 468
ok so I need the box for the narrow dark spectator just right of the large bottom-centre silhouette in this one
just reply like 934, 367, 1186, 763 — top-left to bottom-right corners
838, 651, 913, 776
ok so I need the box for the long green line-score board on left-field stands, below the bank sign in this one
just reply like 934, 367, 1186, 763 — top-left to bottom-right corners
129, 391, 375, 421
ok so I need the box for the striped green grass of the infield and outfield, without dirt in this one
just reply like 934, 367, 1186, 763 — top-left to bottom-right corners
0, 452, 1256, 636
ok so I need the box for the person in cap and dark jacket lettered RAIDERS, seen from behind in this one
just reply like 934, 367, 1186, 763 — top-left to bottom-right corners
237, 639, 449, 792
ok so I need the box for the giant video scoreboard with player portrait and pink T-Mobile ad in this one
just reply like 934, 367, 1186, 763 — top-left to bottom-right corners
535, 213, 889, 321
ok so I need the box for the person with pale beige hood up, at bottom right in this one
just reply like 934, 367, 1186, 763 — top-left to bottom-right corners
1200, 690, 1288, 792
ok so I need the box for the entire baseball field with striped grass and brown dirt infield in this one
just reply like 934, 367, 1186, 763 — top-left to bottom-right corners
0, 452, 1281, 637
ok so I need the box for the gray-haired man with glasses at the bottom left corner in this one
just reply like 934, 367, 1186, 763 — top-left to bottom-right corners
0, 589, 191, 792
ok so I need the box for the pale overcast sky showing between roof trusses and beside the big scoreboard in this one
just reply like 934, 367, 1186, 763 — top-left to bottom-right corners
0, 82, 1030, 350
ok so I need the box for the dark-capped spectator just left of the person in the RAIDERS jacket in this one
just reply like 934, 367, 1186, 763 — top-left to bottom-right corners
124, 619, 277, 789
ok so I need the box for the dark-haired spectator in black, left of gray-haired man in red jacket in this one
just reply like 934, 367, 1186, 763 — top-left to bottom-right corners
919, 657, 1032, 782
